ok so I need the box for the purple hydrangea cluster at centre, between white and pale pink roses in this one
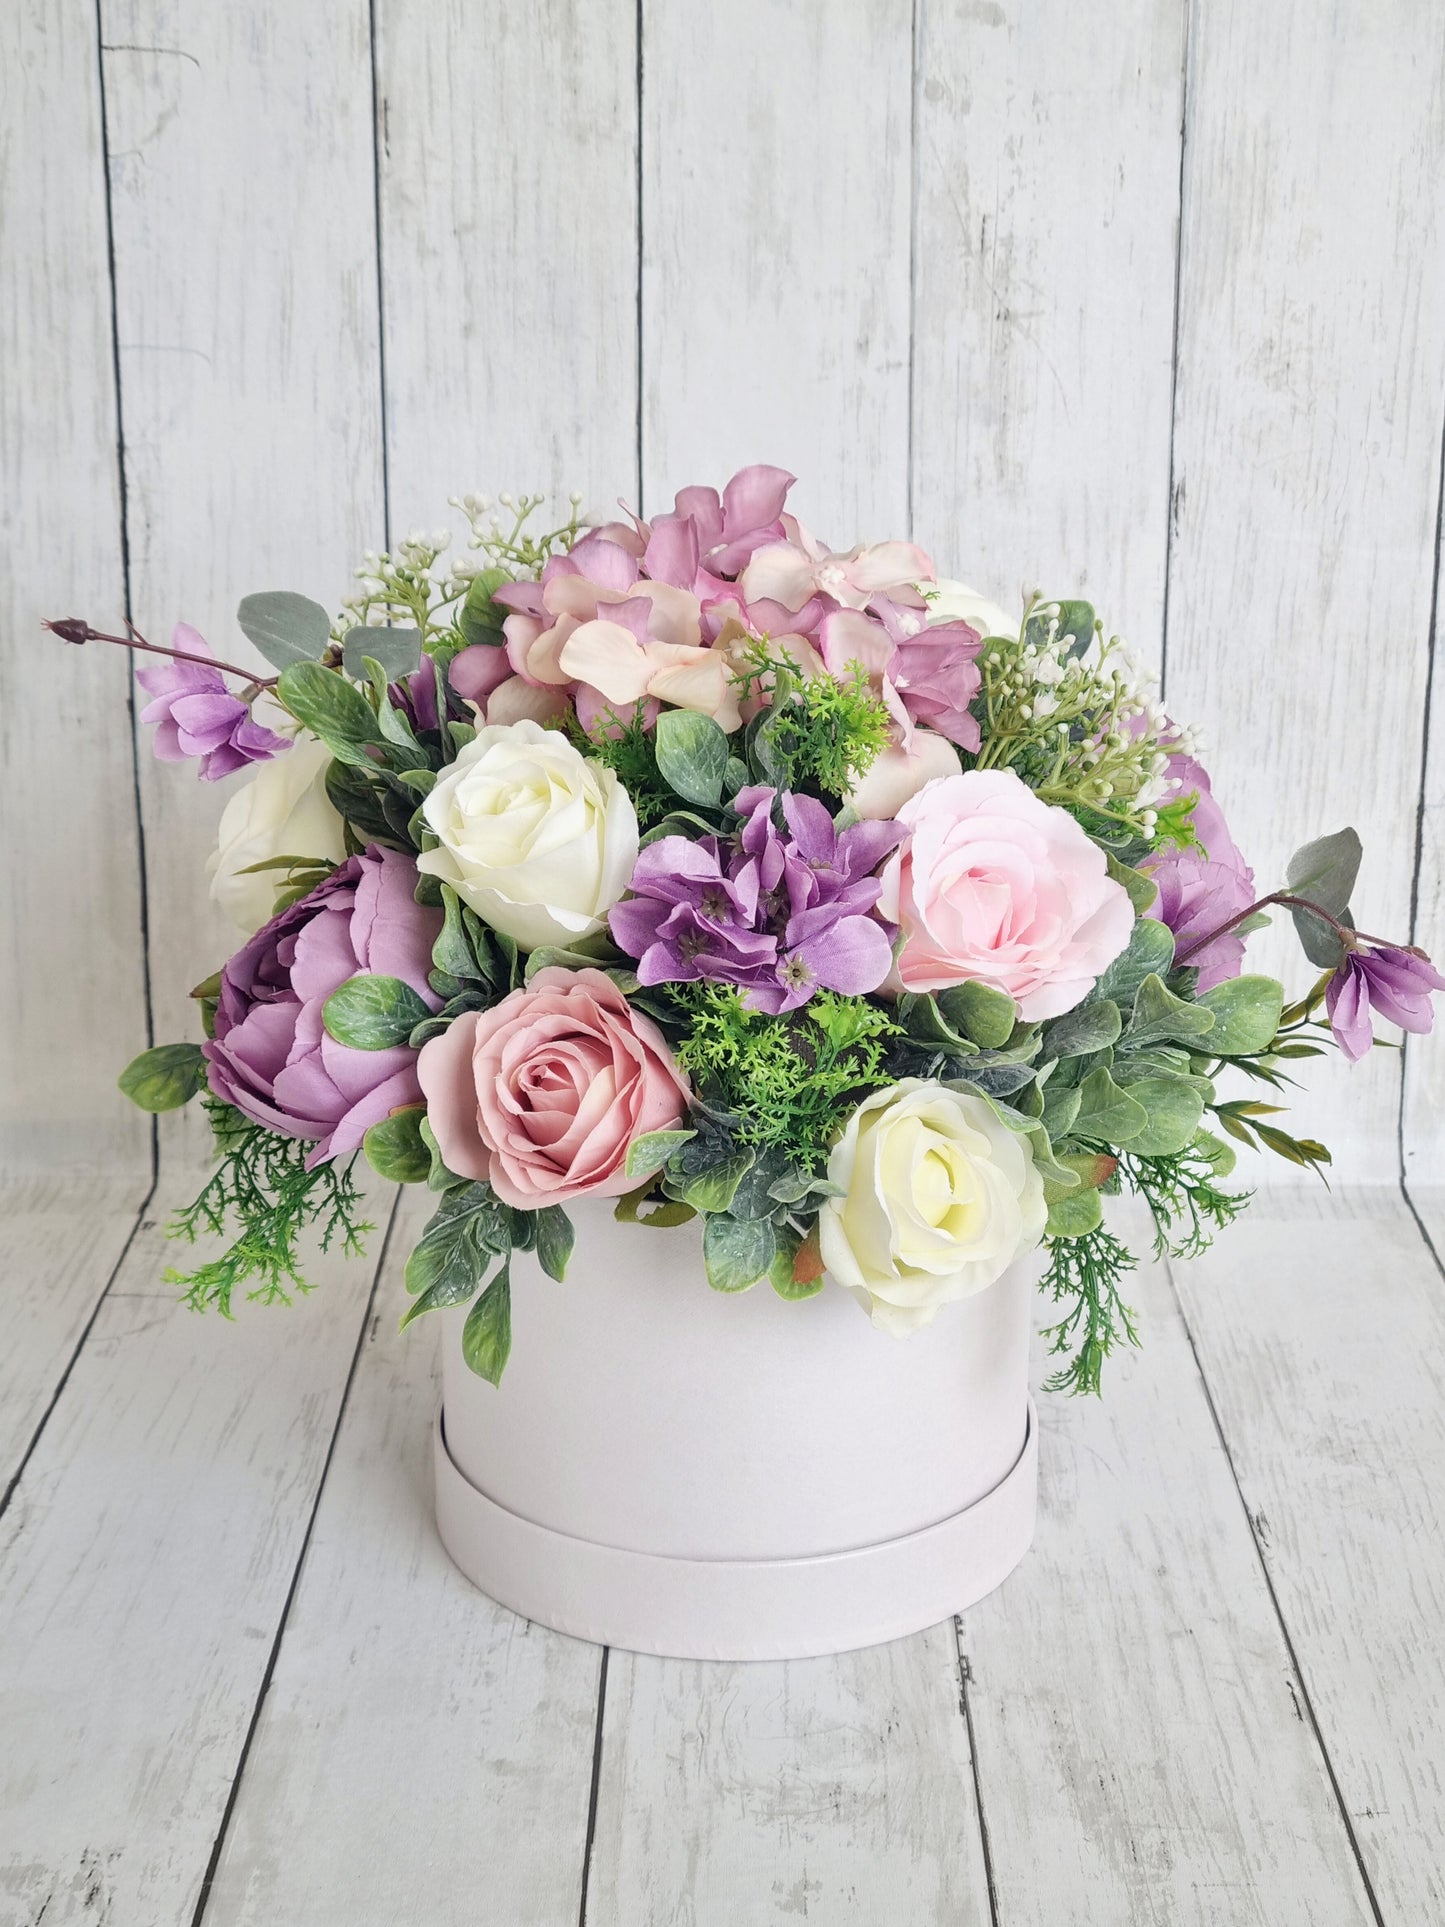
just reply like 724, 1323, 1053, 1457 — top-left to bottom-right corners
609, 784, 904, 1016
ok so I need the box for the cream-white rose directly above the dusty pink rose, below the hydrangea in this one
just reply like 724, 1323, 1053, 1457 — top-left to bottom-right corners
416, 719, 638, 950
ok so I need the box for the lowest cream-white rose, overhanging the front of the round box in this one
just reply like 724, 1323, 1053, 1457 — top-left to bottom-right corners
819, 1077, 1046, 1335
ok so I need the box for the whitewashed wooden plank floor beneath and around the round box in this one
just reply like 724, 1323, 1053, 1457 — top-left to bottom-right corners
0, 1174, 1445, 1927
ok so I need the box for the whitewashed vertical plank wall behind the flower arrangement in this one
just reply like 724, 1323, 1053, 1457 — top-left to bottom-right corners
0, 0, 1445, 1183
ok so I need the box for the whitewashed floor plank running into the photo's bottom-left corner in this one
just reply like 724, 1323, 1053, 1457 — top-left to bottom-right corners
0, 1183, 391, 1927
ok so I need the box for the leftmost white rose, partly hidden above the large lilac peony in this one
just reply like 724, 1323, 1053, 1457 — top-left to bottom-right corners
206, 730, 347, 937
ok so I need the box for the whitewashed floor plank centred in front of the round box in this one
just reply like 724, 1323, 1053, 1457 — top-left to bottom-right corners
586, 1624, 988, 1927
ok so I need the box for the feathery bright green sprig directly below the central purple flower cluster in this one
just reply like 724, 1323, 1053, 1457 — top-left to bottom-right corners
670, 985, 896, 1172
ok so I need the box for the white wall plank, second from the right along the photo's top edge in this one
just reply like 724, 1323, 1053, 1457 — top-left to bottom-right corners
913, 0, 1185, 647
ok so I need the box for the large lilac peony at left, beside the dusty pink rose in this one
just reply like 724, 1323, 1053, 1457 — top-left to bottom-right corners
204, 844, 441, 1170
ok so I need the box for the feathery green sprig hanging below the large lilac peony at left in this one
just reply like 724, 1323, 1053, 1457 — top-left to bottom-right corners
166, 1098, 374, 1318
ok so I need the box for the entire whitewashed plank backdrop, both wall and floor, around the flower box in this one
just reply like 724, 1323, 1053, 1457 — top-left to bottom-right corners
0, 0, 1445, 1927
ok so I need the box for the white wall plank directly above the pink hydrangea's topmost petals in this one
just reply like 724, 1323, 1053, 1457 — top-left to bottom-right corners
638, 0, 911, 547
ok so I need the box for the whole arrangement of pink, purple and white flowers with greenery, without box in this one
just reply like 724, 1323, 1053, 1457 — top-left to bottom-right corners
48, 466, 1445, 1391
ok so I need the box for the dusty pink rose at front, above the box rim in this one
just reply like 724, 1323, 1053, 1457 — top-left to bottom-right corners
416, 965, 692, 1210
